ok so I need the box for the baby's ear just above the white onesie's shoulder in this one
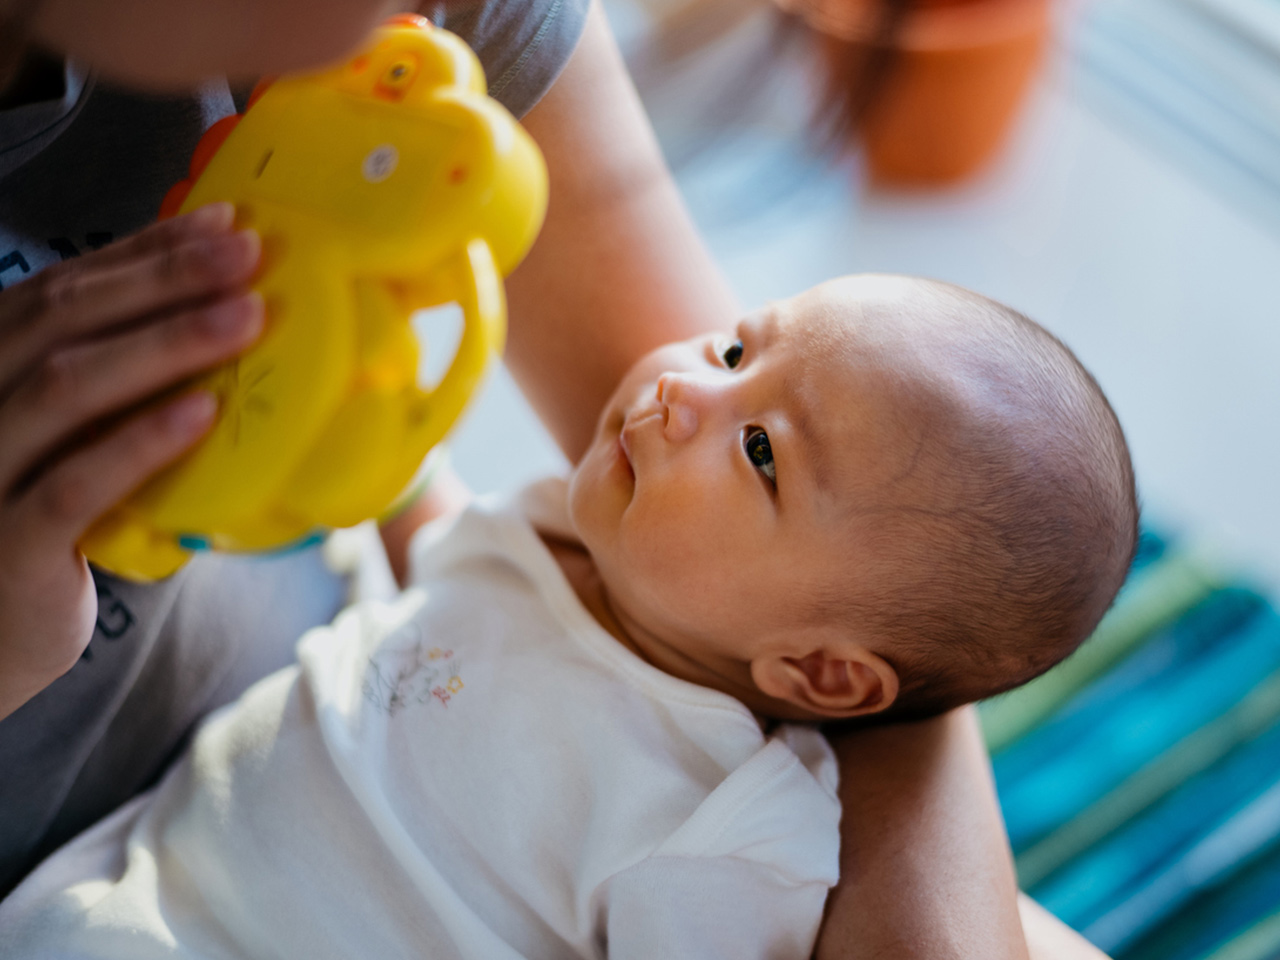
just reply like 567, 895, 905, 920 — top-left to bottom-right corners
751, 641, 899, 719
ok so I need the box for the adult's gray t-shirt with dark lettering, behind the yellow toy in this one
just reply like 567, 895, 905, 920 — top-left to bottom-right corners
0, 0, 586, 897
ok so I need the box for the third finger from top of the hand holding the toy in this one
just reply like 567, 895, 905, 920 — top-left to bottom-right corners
0, 293, 262, 492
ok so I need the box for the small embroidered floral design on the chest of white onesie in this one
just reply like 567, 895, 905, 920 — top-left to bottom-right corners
362, 622, 465, 717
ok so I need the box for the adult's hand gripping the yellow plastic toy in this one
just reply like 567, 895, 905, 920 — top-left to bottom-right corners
0, 205, 262, 718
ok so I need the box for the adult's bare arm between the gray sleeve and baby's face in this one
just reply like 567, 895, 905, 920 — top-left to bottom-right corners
507, 4, 737, 460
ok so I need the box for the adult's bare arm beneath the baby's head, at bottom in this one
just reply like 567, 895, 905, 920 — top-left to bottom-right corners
817, 709, 1028, 960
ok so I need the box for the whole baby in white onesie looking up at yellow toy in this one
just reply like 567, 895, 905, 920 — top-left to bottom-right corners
0, 276, 1137, 960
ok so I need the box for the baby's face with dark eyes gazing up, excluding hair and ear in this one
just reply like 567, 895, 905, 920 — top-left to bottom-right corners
570, 278, 942, 699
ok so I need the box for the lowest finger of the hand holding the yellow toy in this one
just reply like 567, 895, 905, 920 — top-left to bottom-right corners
4, 390, 216, 559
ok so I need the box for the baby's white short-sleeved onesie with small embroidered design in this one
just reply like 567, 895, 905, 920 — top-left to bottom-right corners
0, 480, 840, 960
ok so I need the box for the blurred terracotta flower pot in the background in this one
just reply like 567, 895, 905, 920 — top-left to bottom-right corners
778, 0, 1050, 184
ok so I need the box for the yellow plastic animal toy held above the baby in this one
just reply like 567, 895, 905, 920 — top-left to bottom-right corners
81, 17, 547, 580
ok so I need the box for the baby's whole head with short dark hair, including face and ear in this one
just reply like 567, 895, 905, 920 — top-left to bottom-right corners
570, 276, 1138, 721
